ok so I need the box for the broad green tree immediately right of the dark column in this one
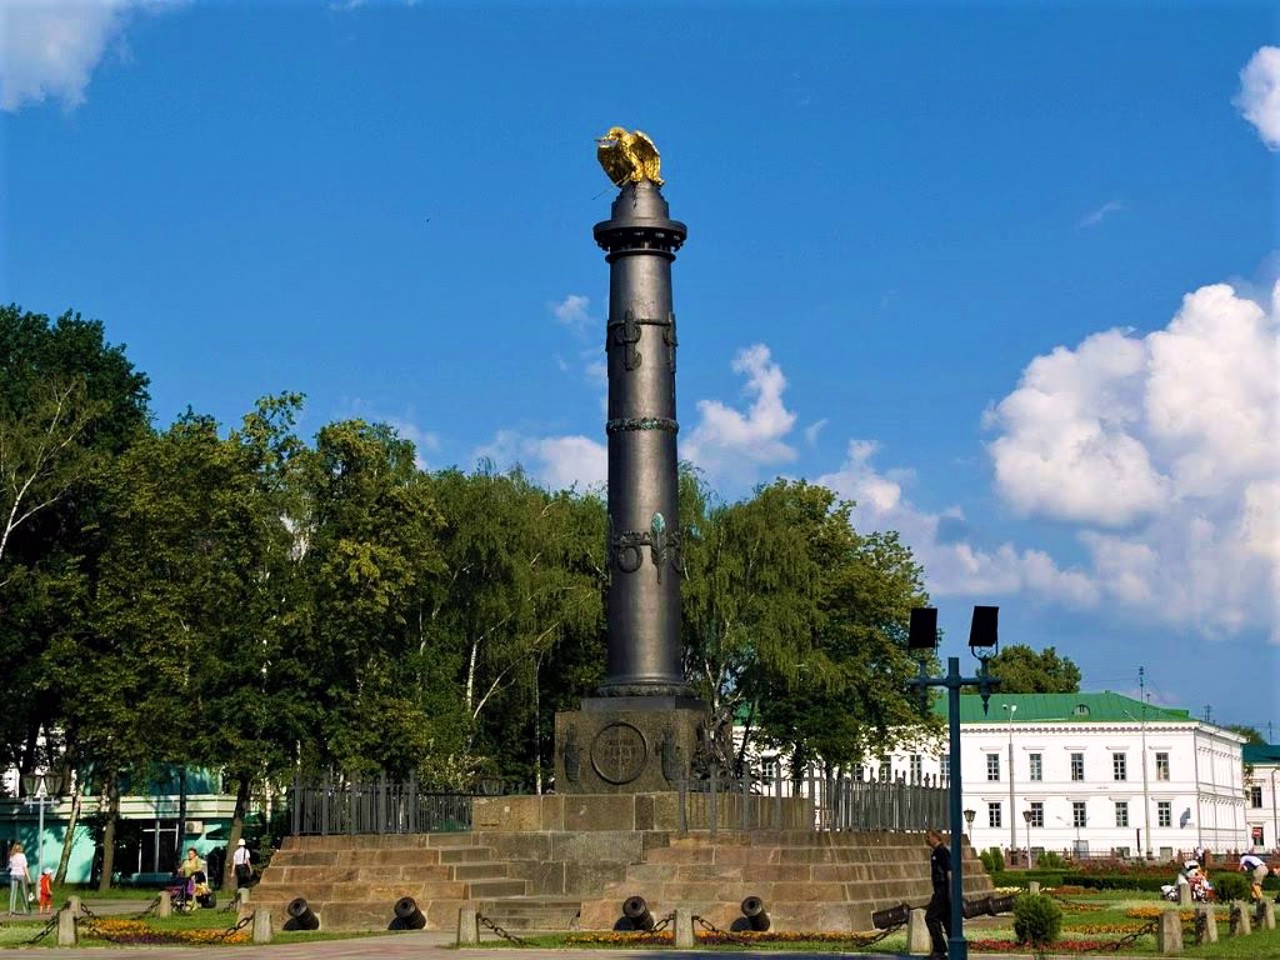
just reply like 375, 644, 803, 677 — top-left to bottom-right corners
681, 472, 924, 771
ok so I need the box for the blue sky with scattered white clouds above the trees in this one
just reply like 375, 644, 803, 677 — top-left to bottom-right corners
0, 0, 1280, 739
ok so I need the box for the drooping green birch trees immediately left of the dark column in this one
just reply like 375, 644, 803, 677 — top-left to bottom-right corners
429, 465, 604, 790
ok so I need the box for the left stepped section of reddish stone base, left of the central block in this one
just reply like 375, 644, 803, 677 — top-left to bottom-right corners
250, 833, 531, 929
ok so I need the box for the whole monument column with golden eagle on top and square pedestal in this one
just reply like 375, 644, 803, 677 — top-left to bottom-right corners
556, 127, 707, 794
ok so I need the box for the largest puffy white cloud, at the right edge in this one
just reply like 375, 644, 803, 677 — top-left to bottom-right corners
987, 277, 1280, 643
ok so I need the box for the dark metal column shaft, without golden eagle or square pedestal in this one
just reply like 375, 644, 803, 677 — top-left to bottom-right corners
595, 180, 689, 696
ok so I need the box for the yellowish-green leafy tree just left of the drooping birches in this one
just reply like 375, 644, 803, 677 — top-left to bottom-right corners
289, 420, 465, 776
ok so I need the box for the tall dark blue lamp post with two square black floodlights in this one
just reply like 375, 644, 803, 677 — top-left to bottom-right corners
906, 607, 1000, 960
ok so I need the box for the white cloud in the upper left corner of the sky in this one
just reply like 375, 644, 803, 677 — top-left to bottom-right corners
0, 0, 173, 111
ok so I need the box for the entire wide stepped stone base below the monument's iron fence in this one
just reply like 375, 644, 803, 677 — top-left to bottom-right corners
251, 829, 991, 932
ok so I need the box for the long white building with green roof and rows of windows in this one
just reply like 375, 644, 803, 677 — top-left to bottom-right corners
890, 692, 1249, 860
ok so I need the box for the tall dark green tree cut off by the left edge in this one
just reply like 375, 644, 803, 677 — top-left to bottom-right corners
0, 305, 150, 799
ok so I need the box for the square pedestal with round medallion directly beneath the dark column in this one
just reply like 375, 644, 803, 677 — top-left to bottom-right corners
556, 696, 709, 794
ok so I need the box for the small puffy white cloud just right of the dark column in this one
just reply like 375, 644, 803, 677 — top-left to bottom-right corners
681, 343, 796, 479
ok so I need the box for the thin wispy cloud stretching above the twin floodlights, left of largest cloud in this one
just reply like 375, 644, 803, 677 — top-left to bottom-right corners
815, 440, 1098, 607
